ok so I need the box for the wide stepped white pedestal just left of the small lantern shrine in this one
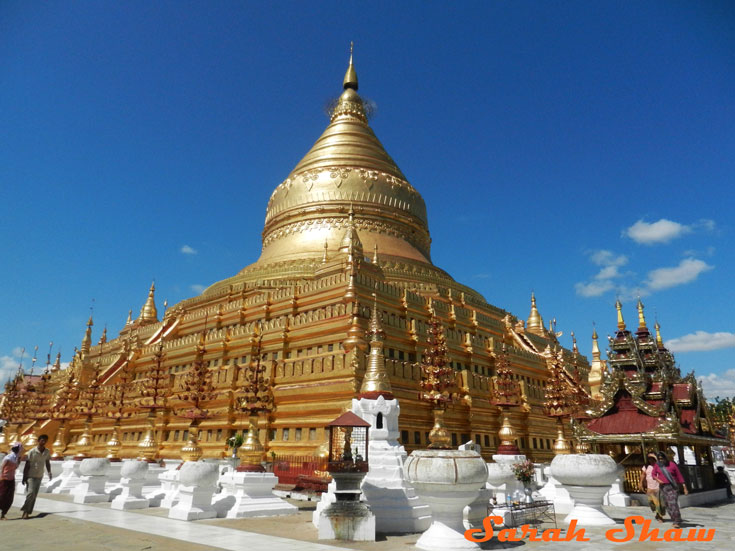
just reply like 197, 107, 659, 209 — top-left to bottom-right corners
212, 470, 299, 518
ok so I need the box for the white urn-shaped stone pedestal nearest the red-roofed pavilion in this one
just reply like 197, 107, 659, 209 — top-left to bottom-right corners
551, 454, 618, 526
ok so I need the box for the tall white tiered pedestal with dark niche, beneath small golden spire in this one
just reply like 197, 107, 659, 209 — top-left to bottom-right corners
350, 396, 431, 534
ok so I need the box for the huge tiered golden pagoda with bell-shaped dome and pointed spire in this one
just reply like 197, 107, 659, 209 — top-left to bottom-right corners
1, 49, 589, 459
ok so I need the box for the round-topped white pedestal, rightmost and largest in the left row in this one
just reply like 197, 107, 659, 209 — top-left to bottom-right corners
168, 461, 219, 520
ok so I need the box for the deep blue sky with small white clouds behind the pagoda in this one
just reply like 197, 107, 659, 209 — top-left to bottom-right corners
0, 1, 735, 402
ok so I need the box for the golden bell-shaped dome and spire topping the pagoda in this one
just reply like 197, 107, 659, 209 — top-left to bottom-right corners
258, 48, 431, 265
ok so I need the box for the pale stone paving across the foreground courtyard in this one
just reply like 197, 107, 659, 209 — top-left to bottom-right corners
0, 496, 735, 551
